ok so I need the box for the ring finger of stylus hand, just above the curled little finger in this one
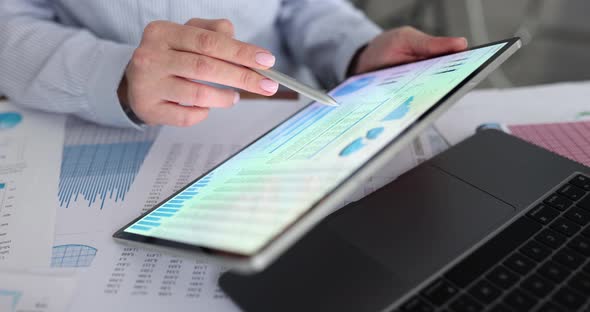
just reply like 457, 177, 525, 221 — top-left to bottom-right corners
160, 77, 240, 108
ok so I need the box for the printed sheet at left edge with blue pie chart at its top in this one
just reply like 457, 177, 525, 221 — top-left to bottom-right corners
0, 103, 64, 269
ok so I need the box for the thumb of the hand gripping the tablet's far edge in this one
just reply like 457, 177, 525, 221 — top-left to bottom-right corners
409, 29, 467, 57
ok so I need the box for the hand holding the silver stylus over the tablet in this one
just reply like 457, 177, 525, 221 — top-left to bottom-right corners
118, 18, 278, 126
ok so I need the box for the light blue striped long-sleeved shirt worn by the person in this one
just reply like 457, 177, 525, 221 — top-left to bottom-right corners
0, 0, 380, 127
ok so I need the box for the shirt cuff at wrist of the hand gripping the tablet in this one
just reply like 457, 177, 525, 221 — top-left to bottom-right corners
334, 20, 382, 81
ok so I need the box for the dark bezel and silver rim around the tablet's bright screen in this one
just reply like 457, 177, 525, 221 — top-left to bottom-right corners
113, 37, 521, 272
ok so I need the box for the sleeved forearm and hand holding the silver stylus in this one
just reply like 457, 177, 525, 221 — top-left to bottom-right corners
0, 0, 278, 127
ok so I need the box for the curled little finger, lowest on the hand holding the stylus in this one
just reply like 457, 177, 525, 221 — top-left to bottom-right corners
149, 102, 209, 127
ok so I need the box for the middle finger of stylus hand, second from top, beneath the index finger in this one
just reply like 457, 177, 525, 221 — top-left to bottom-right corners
163, 51, 279, 95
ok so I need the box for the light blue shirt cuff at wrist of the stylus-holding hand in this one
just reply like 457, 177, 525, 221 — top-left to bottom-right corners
87, 41, 143, 130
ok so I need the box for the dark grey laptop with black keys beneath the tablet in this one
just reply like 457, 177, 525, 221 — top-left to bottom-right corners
219, 125, 590, 312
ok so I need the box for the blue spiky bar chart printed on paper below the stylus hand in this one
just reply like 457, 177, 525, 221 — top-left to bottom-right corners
58, 118, 157, 209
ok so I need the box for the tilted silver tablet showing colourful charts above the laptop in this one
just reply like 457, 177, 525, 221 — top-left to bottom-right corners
114, 38, 520, 272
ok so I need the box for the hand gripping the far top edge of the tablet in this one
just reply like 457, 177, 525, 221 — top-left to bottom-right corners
352, 26, 467, 74
